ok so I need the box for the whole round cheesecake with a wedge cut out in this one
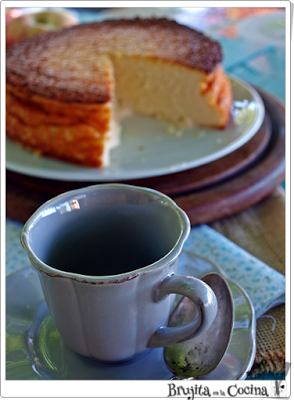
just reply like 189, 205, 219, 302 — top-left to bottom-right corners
6, 18, 232, 168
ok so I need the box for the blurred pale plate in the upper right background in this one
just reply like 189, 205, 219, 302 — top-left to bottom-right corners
238, 12, 285, 47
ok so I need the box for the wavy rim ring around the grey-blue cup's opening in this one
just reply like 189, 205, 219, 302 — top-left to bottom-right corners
20, 183, 191, 284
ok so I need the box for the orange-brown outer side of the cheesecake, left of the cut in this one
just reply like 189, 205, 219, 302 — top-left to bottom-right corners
6, 85, 111, 168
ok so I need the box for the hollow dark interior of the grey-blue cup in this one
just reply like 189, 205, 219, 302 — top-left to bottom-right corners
26, 187, 183, 276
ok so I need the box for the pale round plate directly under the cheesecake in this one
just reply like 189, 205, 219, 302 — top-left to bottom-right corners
6, 74, 264, 182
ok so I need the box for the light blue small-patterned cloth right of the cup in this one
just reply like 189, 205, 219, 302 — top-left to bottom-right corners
181, 225, 285, 318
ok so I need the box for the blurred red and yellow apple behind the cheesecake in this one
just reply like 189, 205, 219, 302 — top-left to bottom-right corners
6, 10, 78, 47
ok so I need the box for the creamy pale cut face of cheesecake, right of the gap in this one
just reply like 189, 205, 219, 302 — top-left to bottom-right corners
112, 56, 231, 127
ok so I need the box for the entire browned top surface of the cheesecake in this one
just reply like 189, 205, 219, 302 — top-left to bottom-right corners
6, 18, 222, 103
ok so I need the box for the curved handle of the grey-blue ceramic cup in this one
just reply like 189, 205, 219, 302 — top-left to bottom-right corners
148, 275, 217, 348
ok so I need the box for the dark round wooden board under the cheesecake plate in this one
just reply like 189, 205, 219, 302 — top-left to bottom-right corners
6, 90, 285, 225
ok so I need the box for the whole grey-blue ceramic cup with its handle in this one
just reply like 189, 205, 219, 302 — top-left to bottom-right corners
21, 184, 217, 362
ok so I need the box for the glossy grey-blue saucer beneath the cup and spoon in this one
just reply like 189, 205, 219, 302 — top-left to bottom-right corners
6, 267, 255, 380
